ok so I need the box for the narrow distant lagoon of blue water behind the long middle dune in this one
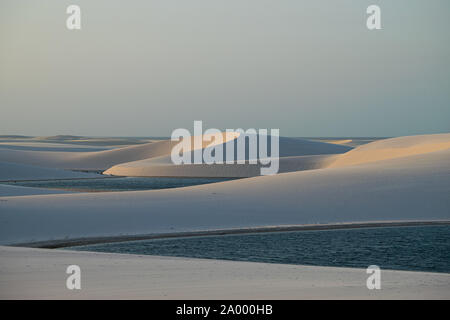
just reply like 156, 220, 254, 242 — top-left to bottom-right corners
4, 177, 231, 192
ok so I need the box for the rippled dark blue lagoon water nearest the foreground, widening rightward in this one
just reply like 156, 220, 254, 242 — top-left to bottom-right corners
70, 226, 450, 273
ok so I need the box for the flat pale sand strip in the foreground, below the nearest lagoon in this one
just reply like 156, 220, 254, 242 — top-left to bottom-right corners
0, 247, 450, 299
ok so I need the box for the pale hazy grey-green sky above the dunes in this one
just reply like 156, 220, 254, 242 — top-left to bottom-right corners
0, 0, 450, 137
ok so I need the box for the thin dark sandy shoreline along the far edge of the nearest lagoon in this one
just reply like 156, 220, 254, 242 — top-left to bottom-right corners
12, 220, 450, 249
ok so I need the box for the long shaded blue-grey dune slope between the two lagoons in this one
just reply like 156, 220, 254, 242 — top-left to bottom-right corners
0, 144, 450, 244
